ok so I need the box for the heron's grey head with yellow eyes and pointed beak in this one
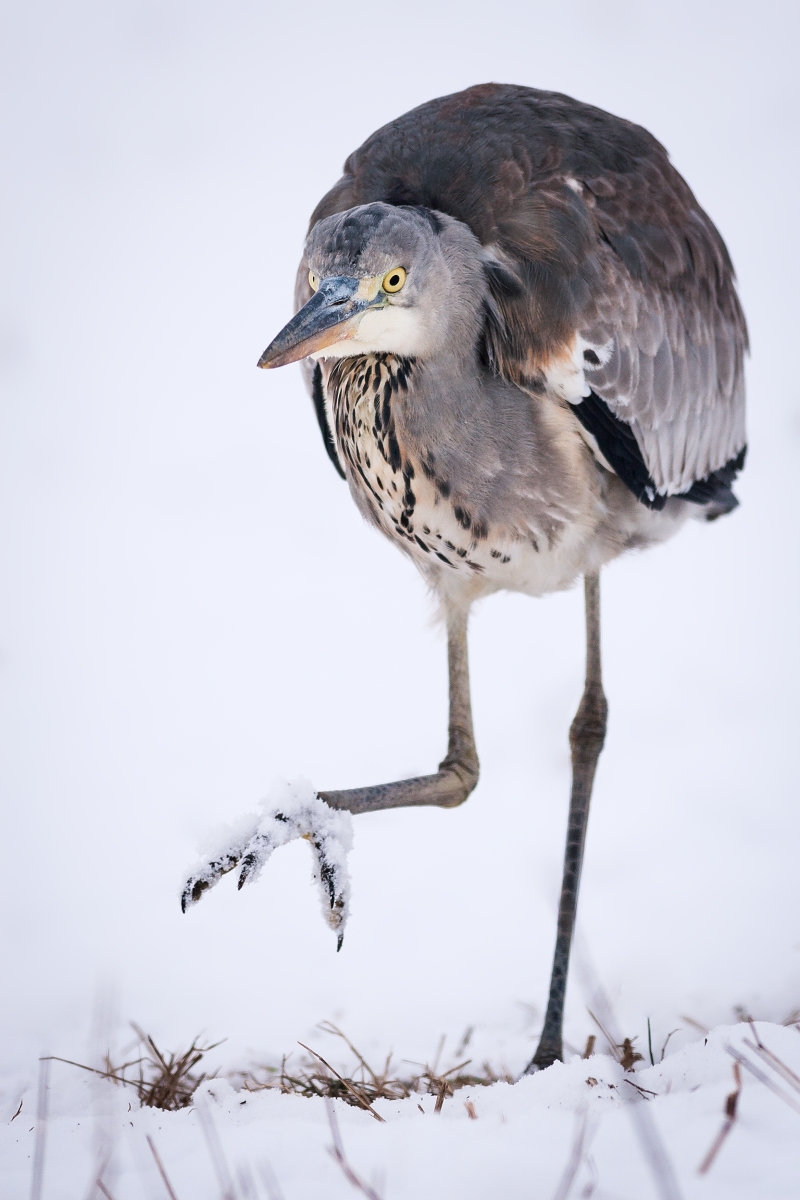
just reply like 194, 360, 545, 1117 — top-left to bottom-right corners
258, 203, 482, 367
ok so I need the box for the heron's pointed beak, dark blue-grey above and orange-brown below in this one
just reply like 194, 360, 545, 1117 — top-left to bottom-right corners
258, 275, 385, 367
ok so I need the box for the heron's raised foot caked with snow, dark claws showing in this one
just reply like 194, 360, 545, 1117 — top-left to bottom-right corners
181, 781, 353, 949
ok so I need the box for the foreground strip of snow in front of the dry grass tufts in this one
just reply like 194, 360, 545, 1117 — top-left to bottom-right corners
0, 1022, 800, 1200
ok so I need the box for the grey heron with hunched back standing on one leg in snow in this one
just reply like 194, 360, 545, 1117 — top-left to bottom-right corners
184, 84, 747, 1070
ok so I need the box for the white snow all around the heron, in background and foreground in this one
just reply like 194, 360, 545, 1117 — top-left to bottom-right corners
0, 0, 800, 1200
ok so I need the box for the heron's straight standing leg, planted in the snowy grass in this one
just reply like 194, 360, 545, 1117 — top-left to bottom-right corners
525, 575, 608, 1075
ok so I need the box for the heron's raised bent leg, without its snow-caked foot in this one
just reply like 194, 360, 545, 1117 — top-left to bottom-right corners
318, 608, 480, 812
